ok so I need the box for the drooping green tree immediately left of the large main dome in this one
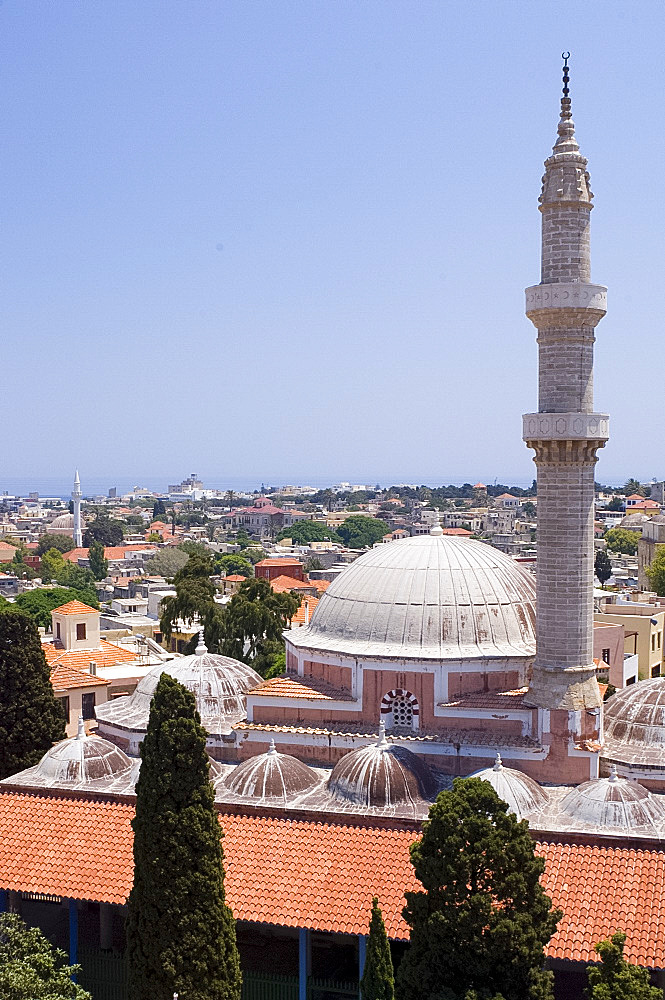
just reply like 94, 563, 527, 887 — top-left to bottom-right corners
215, 578, 300, 676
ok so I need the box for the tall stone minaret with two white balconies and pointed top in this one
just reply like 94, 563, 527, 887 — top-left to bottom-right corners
523, 59, 609, 711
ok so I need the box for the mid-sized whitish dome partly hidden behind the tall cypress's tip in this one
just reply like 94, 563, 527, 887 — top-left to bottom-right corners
95, 641, 263, 735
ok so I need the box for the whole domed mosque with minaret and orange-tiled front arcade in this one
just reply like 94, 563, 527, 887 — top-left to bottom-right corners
0, 56, 665, 1000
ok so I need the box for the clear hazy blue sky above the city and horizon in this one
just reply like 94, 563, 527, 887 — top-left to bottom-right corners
0, 0, 665, 488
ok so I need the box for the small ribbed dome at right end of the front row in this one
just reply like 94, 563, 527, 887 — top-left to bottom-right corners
560, 764, 665, 832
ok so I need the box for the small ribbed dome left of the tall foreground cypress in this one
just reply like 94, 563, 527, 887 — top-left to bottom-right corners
34, 719, 132, 785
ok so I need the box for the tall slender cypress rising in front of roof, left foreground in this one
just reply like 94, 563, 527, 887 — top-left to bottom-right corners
127, 674, 241, 1000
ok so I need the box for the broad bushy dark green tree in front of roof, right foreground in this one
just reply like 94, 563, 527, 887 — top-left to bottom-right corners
397, 778, 561, 1000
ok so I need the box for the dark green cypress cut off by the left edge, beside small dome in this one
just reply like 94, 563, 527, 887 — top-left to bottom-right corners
0, 609, 66, 778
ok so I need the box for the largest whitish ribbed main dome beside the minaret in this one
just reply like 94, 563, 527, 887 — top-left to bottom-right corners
287, 529, 536, 660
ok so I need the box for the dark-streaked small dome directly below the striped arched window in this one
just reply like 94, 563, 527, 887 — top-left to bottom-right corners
328, 723, 436, 806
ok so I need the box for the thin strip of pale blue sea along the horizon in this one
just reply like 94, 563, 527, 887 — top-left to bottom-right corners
0, 470, 532, 499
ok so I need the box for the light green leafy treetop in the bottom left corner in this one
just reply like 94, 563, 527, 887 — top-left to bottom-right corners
0, 913, 92, 1000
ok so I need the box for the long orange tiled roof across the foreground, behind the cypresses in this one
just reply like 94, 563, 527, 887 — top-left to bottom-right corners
0, 791, 665, 969
